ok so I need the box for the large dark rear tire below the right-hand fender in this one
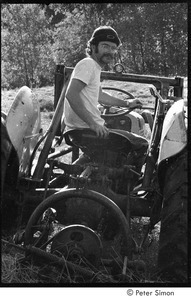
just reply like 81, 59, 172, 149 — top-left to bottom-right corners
158, 150, 188, 283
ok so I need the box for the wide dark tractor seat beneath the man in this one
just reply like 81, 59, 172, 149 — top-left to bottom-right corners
64, 128, 148, 152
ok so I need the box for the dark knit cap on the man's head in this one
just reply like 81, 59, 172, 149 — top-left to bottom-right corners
89, 26, 121, 46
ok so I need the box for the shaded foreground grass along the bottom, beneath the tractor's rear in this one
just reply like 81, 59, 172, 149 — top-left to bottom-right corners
1, 218, 160, 286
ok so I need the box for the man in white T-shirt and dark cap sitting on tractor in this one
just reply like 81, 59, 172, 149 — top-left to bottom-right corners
64, 26, 141, 137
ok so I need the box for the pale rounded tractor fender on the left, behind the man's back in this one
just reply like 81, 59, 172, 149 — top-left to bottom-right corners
6, 86, 41, 175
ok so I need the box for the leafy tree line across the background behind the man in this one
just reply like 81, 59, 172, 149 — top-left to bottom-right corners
1, 3, 188, 89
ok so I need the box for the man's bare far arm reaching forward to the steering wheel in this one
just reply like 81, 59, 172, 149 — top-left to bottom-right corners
99, 87, 142, 108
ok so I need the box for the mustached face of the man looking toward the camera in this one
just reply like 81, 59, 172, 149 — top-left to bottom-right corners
94, 42, 117, 65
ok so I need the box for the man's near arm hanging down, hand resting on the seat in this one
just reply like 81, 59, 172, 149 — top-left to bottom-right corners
66, 78, 108, 137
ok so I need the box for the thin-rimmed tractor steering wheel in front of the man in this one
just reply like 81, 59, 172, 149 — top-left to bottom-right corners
101, 87, 135, 120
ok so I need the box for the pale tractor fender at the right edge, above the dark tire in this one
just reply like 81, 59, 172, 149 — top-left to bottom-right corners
157, 99, 187, 166
